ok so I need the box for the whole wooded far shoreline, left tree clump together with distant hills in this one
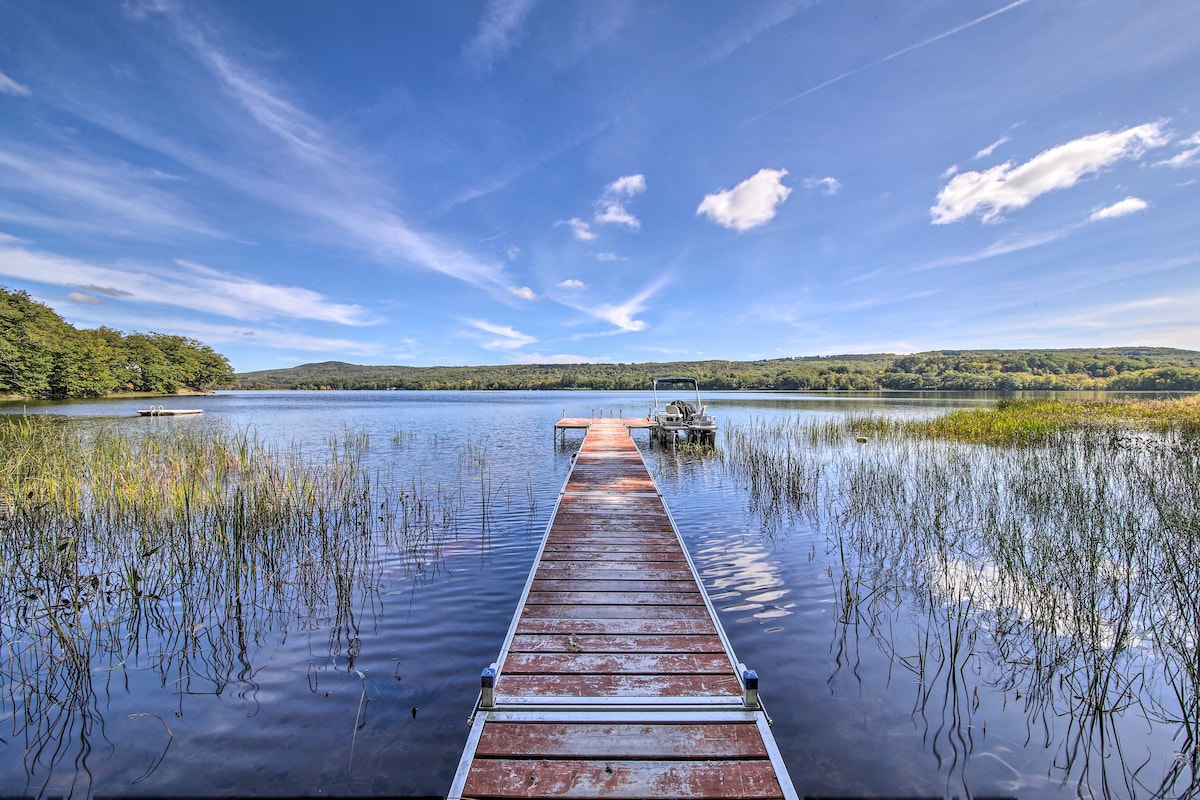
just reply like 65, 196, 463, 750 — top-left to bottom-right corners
0, 285, 1200, 398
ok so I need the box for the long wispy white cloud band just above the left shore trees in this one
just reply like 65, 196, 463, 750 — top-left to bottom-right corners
0, 240, 374, 326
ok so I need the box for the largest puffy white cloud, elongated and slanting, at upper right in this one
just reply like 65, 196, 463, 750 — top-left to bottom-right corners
930, 122, 1170, 224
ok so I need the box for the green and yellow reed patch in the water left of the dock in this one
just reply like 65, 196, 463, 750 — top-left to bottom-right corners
0, 416, 461, 790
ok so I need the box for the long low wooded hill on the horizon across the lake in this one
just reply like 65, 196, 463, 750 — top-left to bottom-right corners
233, 347, 1200, 391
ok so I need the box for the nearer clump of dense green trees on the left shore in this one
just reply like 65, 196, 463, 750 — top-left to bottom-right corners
0, 287, 234, 398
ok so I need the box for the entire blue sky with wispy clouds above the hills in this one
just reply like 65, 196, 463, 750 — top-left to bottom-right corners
0, 0, 1200, 371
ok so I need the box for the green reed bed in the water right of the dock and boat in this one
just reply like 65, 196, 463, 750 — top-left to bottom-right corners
726, 398, 1200, 796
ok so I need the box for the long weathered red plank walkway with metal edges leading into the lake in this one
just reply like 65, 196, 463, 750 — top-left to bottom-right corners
448, 417, 797, 799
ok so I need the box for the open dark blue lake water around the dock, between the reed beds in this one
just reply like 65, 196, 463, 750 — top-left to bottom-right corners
0, 391, 1194, 798
